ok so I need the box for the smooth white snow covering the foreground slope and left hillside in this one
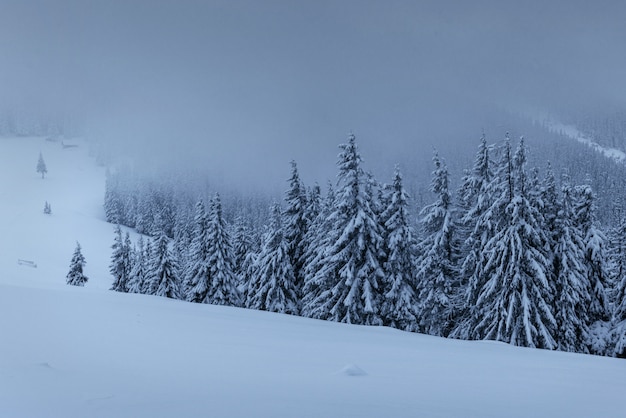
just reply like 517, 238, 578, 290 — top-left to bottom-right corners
0, 138, 626, 418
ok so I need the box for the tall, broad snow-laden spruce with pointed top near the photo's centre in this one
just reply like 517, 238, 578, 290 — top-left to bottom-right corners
304, 134, 384, 325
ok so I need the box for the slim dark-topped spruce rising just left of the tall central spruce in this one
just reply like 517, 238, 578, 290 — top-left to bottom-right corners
283, 161, 308, 299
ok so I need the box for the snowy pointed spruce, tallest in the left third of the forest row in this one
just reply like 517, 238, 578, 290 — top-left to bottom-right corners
207, 193, 242, 306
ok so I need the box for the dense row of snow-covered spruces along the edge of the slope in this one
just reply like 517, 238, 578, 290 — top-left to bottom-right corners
100, 135, 626, 355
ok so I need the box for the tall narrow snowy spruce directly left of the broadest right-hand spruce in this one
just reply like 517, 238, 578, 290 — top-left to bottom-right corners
451, 135, 499, 339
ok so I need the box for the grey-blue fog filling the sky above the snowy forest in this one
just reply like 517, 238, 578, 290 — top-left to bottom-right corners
0, 0, 626, 187
